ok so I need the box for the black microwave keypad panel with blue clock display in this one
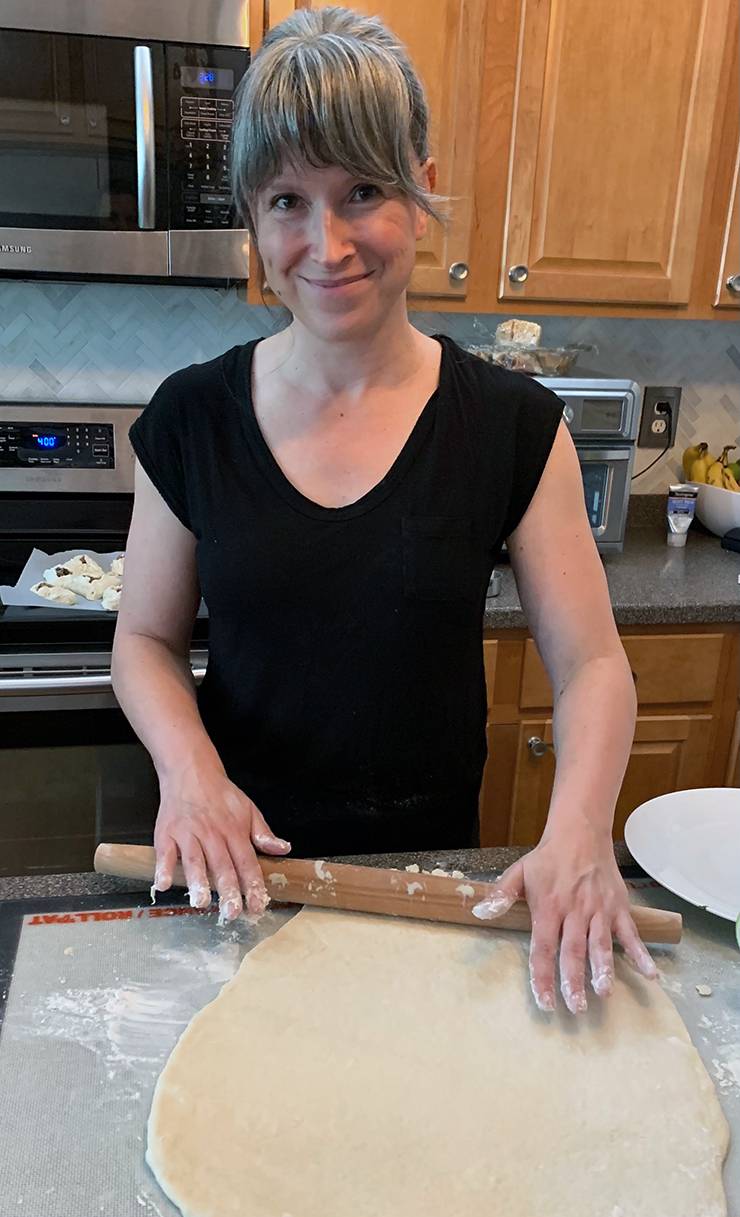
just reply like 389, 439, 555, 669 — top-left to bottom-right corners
167, 45, 250, 229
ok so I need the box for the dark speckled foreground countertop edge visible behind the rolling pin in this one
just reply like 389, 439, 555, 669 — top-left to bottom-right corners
0, 841, 635, 902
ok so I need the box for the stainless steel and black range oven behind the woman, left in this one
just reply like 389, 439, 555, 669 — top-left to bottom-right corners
0, 402, 208, 875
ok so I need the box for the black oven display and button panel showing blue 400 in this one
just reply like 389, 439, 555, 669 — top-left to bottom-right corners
0, 420, 116, 469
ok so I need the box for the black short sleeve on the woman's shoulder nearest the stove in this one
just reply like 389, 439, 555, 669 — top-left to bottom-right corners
129, 372, 192, 531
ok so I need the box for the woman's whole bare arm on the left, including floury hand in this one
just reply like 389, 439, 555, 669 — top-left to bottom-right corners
113, 465, 290, 920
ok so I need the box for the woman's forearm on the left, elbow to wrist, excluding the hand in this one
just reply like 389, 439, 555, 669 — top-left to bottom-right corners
112, 633, 223, 781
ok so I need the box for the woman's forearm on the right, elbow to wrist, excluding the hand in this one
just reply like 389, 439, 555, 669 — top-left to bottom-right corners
546, 652, 637, 835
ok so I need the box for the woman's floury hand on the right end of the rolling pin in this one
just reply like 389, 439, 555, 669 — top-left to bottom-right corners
473, 821, 657, 1014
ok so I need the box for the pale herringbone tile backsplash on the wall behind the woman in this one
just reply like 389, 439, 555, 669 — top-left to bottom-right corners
0, 281, 740, 493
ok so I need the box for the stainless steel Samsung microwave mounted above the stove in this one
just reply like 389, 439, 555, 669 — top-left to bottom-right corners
0, 0, 250, 281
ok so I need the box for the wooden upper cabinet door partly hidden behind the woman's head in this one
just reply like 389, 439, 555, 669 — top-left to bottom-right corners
304, 0, 486, 298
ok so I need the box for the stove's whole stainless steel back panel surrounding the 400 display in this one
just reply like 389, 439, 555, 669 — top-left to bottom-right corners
0, 402, 142, 498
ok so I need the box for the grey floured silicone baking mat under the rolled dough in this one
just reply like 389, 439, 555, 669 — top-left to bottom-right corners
0, 874, 740, 1217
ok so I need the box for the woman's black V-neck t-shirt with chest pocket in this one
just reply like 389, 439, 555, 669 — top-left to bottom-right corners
130, 335, 562, 856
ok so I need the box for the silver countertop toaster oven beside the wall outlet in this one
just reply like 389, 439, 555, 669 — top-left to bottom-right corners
537, 376, 640, 554
